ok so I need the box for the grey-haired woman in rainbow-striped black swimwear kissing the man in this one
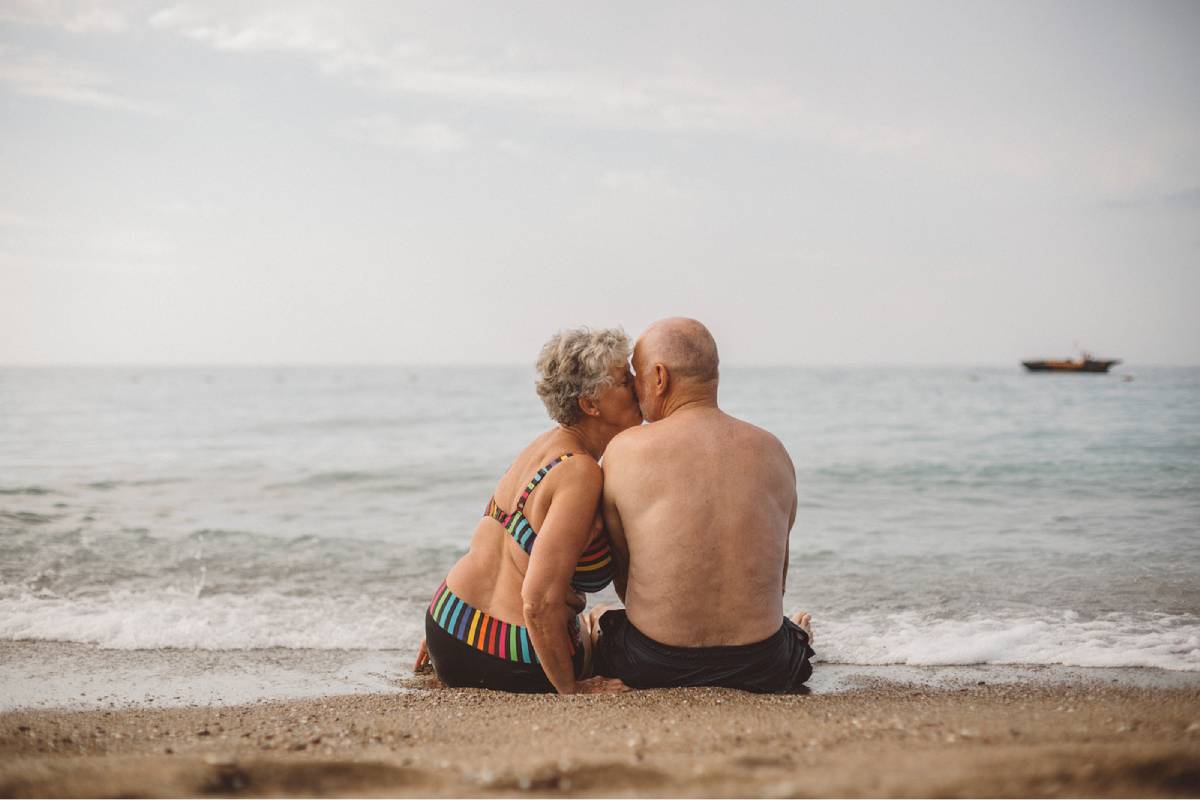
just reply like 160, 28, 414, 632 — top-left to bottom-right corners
416, 329, 642, 694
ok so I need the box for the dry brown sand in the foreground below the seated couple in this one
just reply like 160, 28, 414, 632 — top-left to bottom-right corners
0, 680, 1200, 796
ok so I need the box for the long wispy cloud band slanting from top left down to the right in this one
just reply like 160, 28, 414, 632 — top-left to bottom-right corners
140, 2, 1180, 199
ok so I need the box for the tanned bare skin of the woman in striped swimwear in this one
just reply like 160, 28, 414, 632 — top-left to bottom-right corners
415, 365, 642, 694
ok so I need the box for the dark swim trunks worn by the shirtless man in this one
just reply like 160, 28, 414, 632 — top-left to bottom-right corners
594, 609, 816, 693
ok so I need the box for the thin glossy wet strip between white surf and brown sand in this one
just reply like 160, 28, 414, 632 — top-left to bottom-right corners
0, 640, 1200, 714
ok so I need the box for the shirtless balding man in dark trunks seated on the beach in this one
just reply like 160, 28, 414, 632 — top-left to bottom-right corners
595, 318, 812, 692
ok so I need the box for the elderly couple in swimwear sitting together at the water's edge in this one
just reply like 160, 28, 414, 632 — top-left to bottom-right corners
416, 318, 812, 694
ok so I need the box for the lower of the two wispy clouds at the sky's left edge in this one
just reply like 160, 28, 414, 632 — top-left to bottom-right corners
0, 49, 161, 114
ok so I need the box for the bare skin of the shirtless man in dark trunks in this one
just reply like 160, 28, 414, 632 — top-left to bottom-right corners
602, 320, 811, 646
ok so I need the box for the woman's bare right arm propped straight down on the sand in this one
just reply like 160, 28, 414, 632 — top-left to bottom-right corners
521, 458, 602, 694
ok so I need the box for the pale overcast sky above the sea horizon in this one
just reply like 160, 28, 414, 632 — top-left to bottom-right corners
0, 0, 1200, 365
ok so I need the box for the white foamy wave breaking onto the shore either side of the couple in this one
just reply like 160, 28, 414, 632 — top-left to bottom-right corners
0, 591, 1200, 672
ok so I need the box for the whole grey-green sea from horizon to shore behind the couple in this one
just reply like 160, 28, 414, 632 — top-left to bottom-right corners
0, 367, 1200, 670
